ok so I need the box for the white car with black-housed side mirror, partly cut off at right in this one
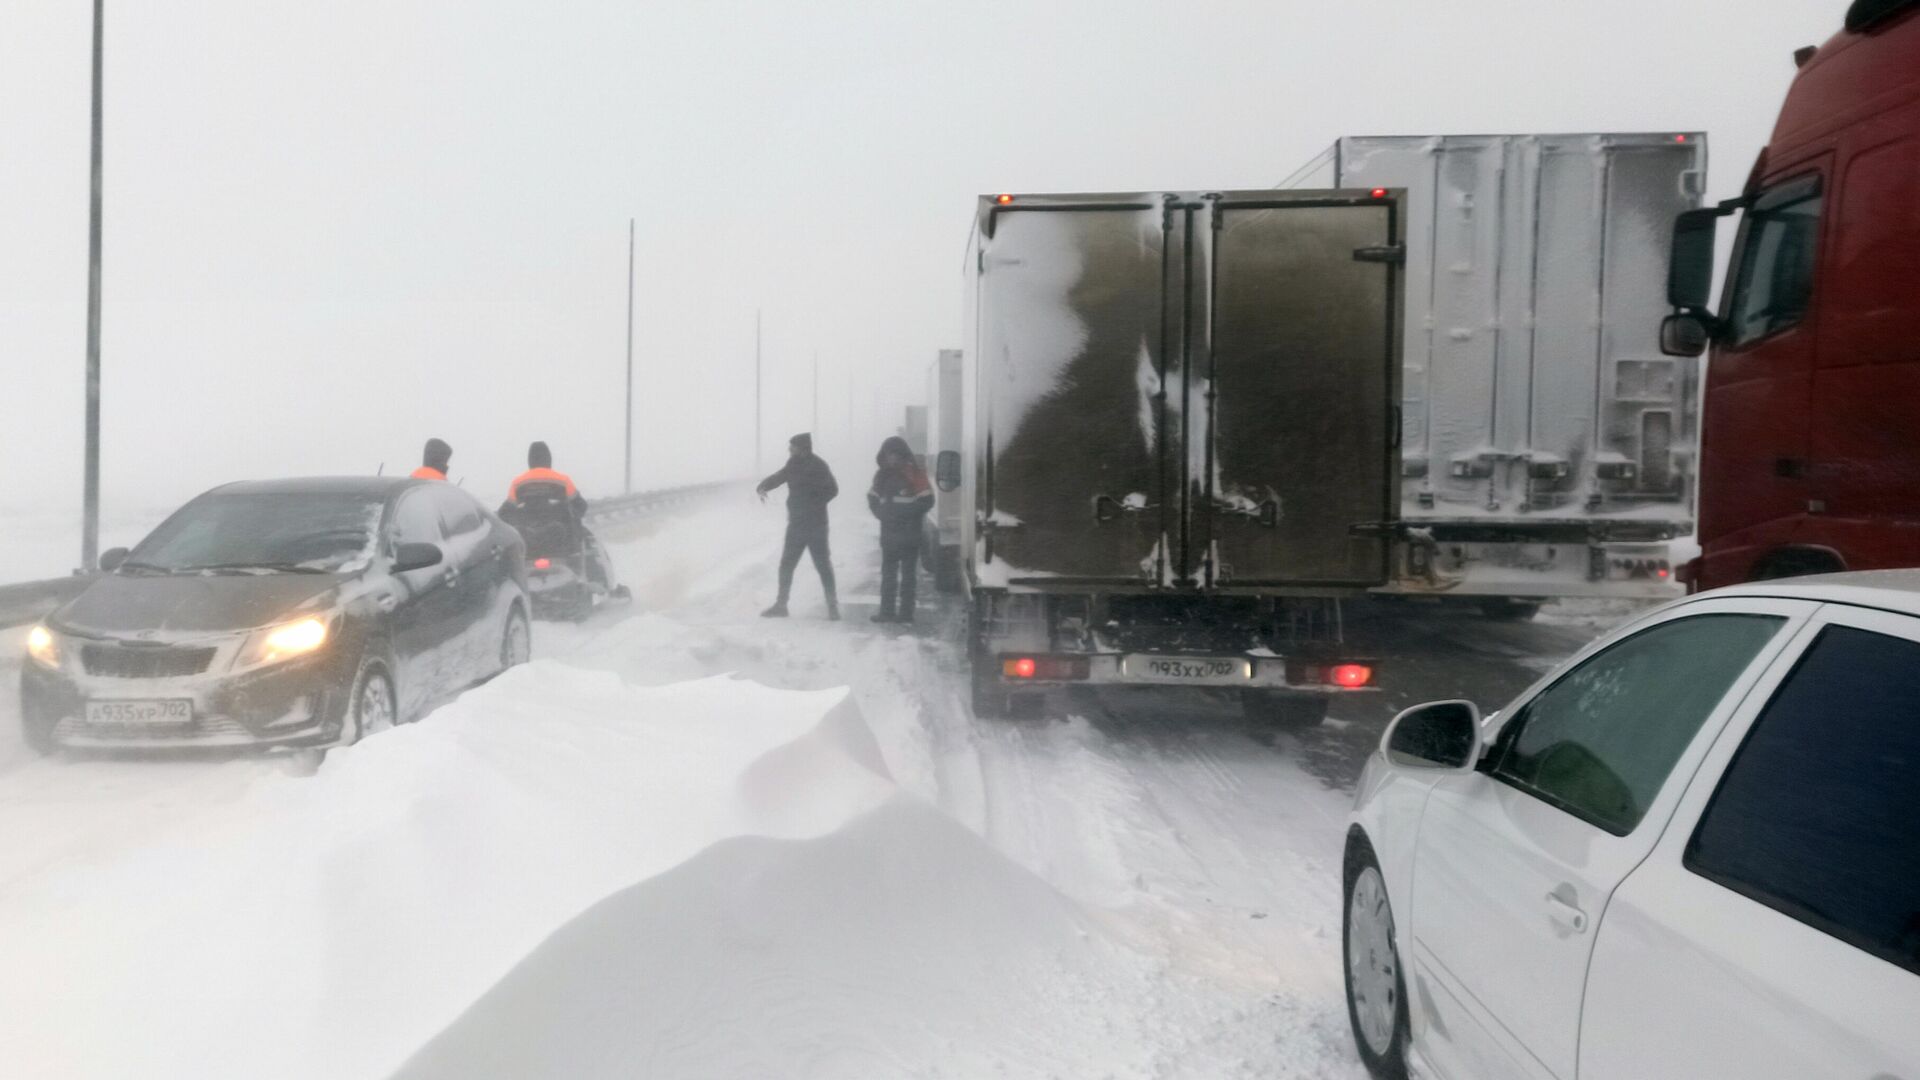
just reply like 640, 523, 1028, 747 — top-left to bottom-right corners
1344, 571, 1920, 1080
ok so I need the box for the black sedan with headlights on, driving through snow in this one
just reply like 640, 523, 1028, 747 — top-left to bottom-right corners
21, 479, 532, 751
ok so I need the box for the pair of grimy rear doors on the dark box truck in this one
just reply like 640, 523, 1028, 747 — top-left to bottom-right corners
975, 188, 1402, 588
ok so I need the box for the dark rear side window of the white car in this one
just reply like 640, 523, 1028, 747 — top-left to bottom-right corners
1686, 626, 1920, 972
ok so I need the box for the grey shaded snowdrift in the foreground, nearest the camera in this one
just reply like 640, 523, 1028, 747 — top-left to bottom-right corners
399, 796, 1144, 1078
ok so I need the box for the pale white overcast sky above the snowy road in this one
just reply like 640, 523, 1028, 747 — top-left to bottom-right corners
0, 0, 1845, 522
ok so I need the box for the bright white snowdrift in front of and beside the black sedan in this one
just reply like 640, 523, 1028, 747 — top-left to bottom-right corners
0, 661, 893, 1078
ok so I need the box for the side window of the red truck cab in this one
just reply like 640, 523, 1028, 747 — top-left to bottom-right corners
1726, 179, 1824, 348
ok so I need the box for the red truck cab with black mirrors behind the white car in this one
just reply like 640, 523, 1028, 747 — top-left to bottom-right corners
1661, 0, 1920, 592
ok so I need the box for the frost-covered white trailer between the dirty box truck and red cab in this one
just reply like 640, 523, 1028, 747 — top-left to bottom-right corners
1283, 133, 1707, 617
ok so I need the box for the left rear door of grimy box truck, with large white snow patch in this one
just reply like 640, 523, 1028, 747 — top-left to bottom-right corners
977, 196, 1177, 584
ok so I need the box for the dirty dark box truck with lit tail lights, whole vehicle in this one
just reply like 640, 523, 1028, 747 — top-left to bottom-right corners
956, 186, 1405, 723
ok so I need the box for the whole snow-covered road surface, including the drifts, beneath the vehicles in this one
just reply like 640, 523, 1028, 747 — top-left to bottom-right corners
0, 500, 1617, 1078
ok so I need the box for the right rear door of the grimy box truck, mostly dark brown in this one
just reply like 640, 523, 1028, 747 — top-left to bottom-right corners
1188, 192, 1402, 586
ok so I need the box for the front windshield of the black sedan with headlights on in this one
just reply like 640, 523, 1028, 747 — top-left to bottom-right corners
121, 492, 382, 573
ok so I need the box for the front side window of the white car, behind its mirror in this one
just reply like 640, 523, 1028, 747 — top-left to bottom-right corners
1488, 613, 1786, 836
